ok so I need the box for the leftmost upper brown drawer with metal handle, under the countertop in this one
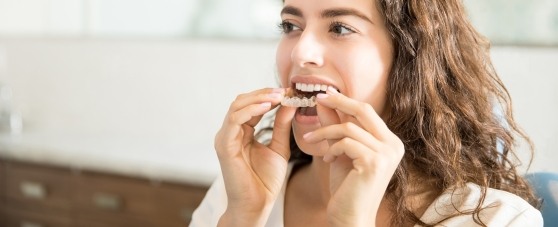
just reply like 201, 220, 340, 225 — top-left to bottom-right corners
5, 162, 72, 211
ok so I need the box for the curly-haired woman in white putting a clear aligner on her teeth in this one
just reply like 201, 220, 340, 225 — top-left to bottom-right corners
191, 0, 542, 226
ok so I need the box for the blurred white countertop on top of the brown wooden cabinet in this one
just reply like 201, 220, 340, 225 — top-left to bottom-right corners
0, 133, 220, 186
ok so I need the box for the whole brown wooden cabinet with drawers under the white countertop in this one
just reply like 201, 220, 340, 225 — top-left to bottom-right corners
0, 160, 207, 227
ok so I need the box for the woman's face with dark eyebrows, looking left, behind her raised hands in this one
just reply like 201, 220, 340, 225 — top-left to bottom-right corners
277, 0, 393, 155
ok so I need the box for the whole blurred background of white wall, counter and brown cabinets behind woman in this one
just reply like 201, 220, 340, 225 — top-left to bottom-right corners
0, 0, 558, 226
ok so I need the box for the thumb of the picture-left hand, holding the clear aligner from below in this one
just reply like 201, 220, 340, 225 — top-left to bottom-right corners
269, 106, 297, 160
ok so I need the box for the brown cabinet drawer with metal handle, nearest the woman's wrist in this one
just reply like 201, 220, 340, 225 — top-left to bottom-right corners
74, 173, 207, 227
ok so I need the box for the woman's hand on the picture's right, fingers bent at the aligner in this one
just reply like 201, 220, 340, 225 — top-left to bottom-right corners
304, 90, 405, 226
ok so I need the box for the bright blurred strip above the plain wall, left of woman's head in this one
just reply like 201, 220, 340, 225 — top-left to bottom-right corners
0, 0, 282, 38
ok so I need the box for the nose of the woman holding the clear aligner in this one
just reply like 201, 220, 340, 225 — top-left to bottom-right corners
291, 33, 325, 68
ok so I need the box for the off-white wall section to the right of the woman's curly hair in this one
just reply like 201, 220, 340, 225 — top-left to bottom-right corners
492, 47, 558, 172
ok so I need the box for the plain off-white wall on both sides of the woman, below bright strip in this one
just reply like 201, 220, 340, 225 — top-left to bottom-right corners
0, 39, 558, 172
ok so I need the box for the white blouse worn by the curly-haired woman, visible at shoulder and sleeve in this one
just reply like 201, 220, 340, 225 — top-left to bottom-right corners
190, 164, 543, 227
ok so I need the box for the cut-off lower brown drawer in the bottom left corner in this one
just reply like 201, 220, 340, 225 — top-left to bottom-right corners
0, 207, 74, 227
